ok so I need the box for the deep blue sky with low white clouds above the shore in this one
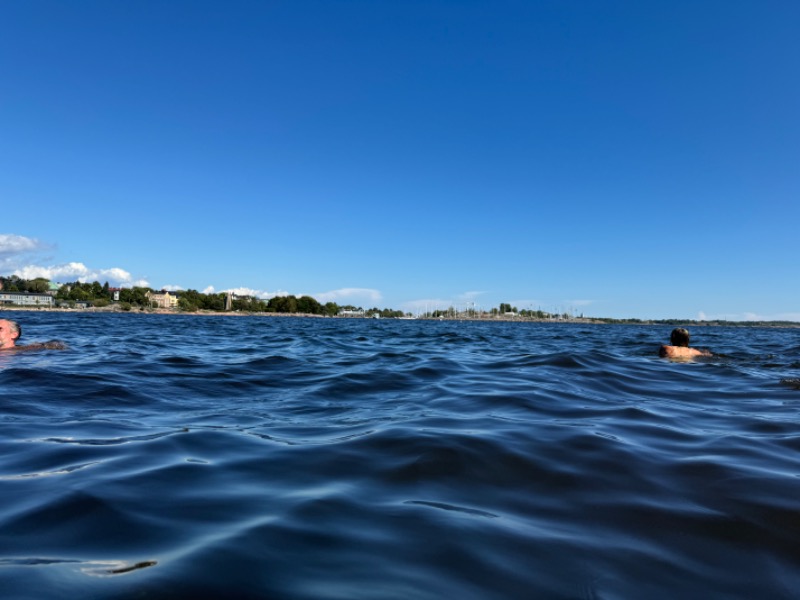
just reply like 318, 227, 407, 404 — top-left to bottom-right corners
0, 0, 800, 321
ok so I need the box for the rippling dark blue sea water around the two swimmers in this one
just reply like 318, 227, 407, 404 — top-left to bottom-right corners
0, 313, 800, 599
